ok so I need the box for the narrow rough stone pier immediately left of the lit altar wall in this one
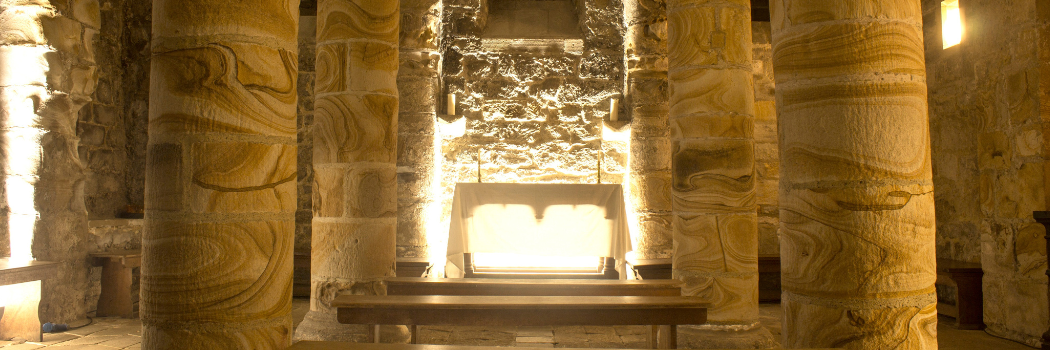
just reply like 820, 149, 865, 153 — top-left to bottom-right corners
397, 0, 446, 261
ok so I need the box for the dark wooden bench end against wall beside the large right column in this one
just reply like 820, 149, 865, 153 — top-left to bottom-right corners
936, 259, 985, 329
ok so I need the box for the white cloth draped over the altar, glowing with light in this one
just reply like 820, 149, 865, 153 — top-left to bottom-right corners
445, 183, 631, 279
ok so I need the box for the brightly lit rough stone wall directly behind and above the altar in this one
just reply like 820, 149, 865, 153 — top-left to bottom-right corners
439, 0, 627, 260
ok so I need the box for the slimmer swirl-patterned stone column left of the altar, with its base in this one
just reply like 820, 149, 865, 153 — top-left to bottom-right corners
295, 0, 400, 341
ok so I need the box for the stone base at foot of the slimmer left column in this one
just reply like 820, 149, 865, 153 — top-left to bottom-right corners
294, 310, 411, 344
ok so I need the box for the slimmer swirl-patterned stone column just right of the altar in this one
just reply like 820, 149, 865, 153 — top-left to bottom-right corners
667, 0, 758, 326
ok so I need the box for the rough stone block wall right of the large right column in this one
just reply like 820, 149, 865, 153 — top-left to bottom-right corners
923, 0, 1050, 346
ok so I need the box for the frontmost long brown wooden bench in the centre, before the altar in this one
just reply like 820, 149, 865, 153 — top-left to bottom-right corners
332, 295, 710, 349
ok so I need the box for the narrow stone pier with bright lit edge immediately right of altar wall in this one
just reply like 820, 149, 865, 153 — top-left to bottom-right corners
624, 0, 673, 259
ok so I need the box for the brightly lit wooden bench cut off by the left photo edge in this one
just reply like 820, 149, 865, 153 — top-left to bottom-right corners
0, 258, 59, 342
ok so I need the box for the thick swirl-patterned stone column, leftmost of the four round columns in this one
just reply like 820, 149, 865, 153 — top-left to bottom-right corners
141, 0, 299, 349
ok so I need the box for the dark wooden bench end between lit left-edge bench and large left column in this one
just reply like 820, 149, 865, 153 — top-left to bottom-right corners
89, 250, 142, 318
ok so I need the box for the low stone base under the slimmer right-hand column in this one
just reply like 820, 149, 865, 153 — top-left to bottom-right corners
678, 323, 780, 349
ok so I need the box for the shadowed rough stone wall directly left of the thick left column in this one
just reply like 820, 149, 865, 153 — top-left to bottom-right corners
77, 0, 152, 220
